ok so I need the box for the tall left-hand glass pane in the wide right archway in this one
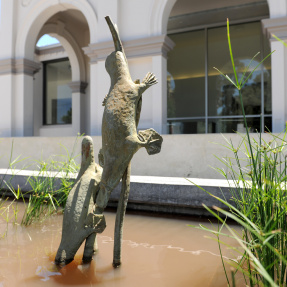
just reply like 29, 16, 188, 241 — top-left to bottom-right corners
167, 30, 205, 118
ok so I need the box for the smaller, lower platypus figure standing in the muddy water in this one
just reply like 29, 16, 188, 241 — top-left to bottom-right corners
55, 136, 105, 265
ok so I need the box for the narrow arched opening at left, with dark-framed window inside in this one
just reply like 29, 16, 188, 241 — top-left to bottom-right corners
30, 9, 90, 136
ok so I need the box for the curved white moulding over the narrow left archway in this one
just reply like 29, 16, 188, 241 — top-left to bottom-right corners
15, 0, 98, 60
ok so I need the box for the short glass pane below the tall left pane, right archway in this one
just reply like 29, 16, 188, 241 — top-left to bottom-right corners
168, 119, 205, 134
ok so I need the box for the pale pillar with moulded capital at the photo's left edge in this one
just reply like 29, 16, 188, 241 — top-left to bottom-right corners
0, 59, 40, 137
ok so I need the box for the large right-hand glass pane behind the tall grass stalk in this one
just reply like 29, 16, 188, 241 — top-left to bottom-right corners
208, 22, 261, 116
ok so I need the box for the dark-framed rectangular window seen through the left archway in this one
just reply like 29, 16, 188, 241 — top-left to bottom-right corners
43, 59, 72, 125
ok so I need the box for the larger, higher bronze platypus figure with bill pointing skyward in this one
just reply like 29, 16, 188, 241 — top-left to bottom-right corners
87, 16, 162, 266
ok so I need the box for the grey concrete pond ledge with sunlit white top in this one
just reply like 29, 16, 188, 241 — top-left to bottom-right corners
0, 169, 236, 215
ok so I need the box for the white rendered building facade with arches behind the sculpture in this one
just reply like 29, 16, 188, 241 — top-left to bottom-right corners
0, 0, 287, 137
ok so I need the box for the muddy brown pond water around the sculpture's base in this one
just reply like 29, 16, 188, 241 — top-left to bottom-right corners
0, 203, 244, 287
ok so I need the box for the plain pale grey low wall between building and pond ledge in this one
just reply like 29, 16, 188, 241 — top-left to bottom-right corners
0, 134, 276, 179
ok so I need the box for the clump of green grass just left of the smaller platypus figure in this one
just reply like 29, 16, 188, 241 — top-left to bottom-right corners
21, 137, 79, 225
